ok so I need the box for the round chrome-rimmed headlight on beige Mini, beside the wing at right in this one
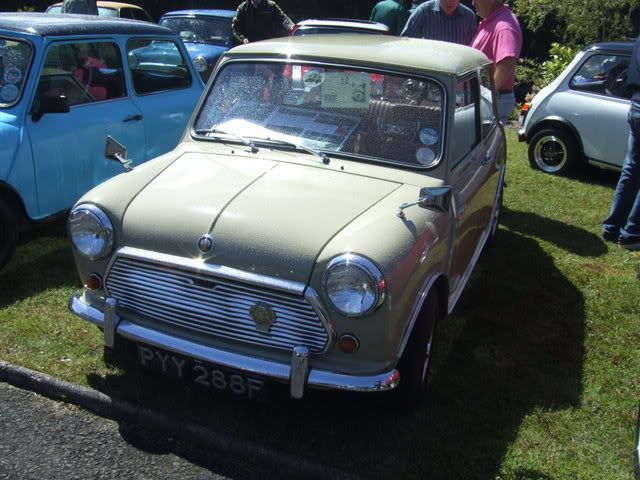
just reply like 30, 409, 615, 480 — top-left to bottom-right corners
322, 253, 386, 317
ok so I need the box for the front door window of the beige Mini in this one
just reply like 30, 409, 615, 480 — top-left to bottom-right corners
451, 77, 480, 167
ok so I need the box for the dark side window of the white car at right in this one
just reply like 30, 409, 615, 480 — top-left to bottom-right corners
569, 54, 631, 98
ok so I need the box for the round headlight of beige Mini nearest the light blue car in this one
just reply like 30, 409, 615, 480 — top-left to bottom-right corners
68, 205, 113, 260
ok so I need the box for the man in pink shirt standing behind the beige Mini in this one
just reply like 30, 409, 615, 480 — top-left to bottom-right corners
471, 0, 522, 124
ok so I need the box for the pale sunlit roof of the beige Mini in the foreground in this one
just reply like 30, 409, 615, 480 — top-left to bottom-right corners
225, 34, 490, 75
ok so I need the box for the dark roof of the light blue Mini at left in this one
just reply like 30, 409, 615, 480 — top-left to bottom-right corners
0, 13, 176, 37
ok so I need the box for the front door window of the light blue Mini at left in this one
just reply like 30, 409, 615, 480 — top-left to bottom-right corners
36, 42, 127, 106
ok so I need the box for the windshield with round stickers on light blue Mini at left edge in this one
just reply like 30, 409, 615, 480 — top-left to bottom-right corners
0, 37, 32, 108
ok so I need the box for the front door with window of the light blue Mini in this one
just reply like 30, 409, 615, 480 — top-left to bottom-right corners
26, 39, 146, 216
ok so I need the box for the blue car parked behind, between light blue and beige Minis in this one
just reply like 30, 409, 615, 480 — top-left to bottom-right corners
160, 10, 236, 82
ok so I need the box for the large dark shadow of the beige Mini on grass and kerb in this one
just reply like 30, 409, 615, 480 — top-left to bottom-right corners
88, 226, 584, 479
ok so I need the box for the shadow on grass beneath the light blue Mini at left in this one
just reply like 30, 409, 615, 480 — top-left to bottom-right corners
0, 220, 78, 309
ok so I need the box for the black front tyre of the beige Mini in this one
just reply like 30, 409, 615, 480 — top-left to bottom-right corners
391, 293, 441, 408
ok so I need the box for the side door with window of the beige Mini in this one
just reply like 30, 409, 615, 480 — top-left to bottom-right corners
449, 70, 502, 303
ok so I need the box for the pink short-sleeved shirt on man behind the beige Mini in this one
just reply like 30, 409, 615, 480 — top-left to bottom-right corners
471, 5, 522, 89
